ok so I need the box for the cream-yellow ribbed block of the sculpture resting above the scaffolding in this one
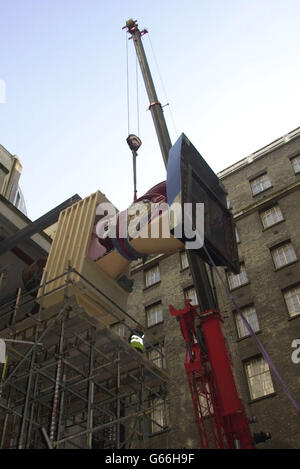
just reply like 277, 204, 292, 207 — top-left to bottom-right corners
38, 191, 129, 324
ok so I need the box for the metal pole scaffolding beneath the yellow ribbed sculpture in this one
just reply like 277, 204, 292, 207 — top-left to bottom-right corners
0, 265, 169, 449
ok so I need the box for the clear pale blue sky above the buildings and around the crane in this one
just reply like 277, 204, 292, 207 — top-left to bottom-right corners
0, 0, 300, 220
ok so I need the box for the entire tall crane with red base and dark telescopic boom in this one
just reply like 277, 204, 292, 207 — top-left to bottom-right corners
123, 19, 254, 449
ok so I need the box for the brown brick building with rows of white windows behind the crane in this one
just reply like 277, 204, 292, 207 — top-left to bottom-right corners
128, 128, 300, 448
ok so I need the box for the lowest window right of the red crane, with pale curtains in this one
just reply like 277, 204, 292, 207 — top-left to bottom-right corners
245, 357, 274, 399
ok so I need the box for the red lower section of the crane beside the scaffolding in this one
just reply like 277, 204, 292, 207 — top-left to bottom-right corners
169, 300, 254, 449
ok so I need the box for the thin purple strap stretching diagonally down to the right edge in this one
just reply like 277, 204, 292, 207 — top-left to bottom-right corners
203, 245, 300, 415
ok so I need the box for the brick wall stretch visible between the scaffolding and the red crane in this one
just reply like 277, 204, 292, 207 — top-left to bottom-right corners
128, 251, 199, 448
